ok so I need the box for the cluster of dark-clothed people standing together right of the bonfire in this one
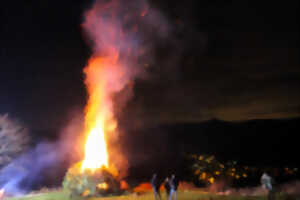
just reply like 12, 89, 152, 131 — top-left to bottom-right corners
151, 174, 179, 200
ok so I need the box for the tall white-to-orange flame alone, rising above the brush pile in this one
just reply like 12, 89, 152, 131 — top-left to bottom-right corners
81, 57, 116, 171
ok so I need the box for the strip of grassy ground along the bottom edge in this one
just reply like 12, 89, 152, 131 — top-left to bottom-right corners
7, 191, 267, 200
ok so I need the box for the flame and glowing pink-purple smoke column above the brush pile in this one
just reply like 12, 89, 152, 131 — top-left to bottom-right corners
81, 0, 147, 173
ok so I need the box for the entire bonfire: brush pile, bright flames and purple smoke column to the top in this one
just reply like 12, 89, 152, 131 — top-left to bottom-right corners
63, 1, 147, 196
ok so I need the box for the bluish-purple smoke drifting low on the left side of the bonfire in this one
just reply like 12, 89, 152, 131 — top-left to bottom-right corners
0, 112, 83, 195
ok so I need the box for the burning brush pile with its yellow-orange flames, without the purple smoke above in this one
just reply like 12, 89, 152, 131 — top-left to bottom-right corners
63, 57, 121, 196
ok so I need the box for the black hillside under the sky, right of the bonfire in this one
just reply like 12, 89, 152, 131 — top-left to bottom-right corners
123, 118, 300, 167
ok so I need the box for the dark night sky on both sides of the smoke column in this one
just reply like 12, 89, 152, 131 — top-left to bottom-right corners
0, 0, 300, 134
